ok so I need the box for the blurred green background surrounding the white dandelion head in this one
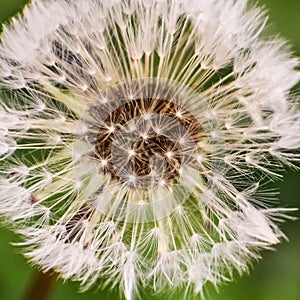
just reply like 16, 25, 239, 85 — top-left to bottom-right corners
0, 0, 300, 300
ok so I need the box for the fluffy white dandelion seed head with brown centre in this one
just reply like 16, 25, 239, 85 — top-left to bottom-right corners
0, 0, 300, 300
